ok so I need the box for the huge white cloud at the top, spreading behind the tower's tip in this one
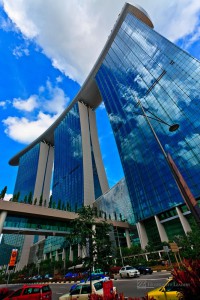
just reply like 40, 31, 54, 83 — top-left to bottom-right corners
3, 0, 200, 83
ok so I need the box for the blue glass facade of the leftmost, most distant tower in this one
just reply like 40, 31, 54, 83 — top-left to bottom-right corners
14, 144, 40, 202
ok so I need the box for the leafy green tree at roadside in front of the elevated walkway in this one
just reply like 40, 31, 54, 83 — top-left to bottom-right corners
69, 206, 112, 269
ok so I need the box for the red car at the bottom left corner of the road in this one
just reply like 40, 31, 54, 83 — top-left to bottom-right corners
4, 284, 52, 300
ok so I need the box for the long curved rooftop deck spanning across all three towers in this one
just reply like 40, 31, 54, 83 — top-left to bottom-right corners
9, 3, 154, 166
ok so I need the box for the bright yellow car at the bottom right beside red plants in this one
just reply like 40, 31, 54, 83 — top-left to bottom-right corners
146, 279, 184, 300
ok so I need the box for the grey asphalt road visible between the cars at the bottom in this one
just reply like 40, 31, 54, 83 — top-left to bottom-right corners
0, 272, 170, 300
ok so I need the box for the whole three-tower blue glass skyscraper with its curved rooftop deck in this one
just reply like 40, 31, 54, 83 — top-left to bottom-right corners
4, 3, 200, 262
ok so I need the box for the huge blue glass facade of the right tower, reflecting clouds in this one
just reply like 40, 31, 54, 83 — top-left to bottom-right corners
96, 14, 200, 221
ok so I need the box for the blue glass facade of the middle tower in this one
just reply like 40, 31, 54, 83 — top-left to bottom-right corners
52, 103, 84, 211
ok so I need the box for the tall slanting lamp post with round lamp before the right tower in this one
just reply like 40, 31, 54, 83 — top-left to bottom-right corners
137, 99, 200, 226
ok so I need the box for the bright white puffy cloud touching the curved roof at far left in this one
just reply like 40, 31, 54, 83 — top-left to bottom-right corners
3, 112, 58, 144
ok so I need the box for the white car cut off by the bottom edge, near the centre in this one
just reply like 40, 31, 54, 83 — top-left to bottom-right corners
59, 280, 116, 300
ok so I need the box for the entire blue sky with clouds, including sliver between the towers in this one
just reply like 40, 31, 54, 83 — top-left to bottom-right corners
0, 0, 200, 199
